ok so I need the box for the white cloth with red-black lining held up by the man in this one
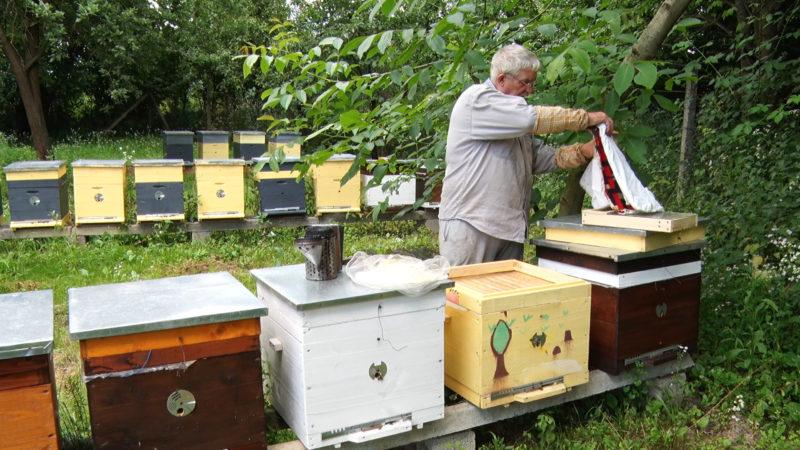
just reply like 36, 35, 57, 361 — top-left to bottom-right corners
581, 124, 664, 212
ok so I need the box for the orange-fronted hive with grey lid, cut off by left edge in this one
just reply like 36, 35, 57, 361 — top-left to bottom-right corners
0, 291, 59, 450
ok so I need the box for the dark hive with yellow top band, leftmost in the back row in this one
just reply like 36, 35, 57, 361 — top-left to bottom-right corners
4, 161, 69, 229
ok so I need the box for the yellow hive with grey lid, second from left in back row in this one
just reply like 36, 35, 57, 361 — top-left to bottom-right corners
72, 159, 125, 225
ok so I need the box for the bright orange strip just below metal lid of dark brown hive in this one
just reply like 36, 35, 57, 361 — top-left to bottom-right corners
81, 318, 261, 360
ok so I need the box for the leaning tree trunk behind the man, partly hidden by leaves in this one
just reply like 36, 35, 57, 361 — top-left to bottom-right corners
558, 0, 689, 216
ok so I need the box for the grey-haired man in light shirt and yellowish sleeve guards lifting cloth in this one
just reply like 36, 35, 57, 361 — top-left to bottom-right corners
439, 44, 614, 265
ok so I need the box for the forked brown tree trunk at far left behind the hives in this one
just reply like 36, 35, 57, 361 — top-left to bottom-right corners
0, 24, 50, 159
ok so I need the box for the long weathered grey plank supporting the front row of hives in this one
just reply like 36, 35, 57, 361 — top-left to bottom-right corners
269, 355, 694, 450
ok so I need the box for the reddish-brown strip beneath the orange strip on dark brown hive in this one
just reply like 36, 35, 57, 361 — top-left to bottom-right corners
83, 335, 260, 375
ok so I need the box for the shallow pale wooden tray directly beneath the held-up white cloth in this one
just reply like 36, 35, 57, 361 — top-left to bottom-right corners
581, 209, 697, 233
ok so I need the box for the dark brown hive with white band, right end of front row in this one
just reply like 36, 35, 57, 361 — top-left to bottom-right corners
534, 239, 704, 374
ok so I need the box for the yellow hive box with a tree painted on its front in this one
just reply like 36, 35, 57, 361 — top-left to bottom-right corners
444, 260, 591, 408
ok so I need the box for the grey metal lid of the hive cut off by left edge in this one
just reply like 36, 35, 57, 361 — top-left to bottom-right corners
0, 290, 53, 359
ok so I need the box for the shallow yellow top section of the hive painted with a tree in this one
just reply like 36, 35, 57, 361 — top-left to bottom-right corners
448, 260, 590, 314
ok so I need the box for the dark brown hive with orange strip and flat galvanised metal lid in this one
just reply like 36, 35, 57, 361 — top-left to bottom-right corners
69, 273, 266, 450
